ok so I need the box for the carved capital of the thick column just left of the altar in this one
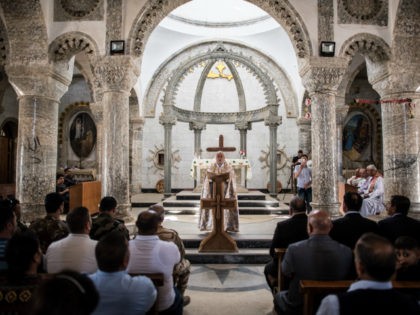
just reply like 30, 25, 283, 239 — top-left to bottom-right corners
92, 55, 140, 92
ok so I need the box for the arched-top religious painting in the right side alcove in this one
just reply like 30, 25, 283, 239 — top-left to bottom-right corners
343, 113, 372, 161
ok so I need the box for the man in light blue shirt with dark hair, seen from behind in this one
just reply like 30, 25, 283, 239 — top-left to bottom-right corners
90, 231, 156, 315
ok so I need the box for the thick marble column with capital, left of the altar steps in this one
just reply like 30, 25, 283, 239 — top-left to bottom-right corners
93, 55, 140, 220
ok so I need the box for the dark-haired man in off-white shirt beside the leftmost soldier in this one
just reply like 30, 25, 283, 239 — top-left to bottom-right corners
45, 207, 98, 273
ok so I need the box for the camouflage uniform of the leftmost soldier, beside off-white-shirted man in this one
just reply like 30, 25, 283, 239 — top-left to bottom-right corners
29, 214, 69, 254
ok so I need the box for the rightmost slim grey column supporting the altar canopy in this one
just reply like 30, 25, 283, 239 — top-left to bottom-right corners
264, 115, 281, 198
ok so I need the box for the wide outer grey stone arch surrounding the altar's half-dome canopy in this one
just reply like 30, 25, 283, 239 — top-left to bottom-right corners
142, 41, 299, 118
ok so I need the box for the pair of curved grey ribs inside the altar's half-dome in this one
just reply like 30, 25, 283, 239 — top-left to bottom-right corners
194, 59, 246, 112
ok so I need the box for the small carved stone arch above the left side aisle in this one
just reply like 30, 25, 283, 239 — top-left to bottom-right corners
48, 32, 99, 61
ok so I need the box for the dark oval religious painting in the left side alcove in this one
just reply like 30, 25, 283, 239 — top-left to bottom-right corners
70, 113, 96, 159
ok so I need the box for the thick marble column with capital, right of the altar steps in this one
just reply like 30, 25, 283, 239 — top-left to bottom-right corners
300, 57, 347, 215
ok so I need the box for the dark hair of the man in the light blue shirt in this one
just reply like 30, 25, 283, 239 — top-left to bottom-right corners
95, 231, 128, 272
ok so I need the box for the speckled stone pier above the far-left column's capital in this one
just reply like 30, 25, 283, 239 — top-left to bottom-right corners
0, 0, 48, 64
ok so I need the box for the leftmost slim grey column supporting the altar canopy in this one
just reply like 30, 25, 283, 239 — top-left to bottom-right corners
159, 114, 176, 197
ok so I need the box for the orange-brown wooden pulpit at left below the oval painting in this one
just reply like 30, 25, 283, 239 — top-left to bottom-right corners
69, 181, 101, 214
